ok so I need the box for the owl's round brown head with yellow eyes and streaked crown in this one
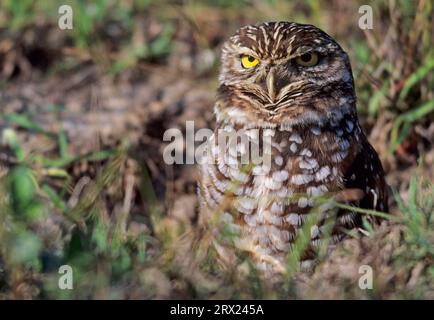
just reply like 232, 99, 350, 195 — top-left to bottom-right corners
216, 22, 355, 126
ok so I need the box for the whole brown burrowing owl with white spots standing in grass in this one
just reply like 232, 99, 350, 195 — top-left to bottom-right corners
199, 22, 388, 270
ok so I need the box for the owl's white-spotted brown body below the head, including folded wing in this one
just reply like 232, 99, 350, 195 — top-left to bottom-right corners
199, 112, 387, 270
